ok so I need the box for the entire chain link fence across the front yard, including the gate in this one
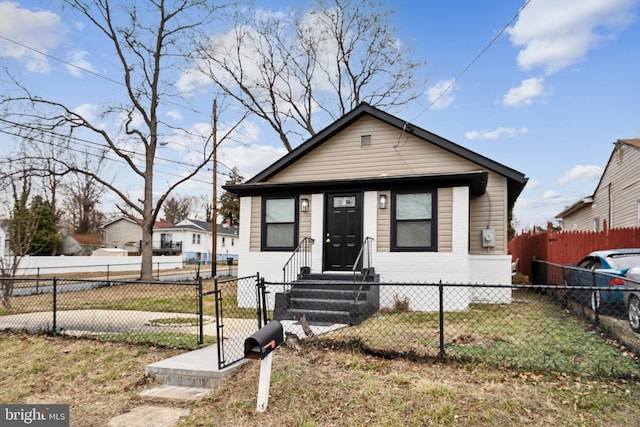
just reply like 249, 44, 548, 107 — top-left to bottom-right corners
0, 270, 640, 378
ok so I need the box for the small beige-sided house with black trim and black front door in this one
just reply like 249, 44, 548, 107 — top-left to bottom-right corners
224, 103, 527, 309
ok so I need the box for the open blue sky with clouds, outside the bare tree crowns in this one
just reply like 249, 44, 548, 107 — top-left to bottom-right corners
0, 0, 640, 230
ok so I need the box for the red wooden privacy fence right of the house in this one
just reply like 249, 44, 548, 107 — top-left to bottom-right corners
509, 221, 640, 277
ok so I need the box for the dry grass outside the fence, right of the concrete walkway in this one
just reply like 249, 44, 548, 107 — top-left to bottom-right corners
181, 347, 640, 426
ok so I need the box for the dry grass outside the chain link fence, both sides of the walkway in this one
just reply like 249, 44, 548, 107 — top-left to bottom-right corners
0, 334, 640, 427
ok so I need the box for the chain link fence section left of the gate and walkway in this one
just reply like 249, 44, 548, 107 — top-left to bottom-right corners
0, 278, 206, 349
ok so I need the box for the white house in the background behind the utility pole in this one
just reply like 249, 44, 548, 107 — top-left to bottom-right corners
153, 219, 238, 263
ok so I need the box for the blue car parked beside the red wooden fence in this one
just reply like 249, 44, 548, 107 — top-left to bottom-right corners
565, 248, 640, 312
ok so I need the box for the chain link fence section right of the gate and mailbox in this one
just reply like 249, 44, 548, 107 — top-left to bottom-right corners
271, 282, 640, 378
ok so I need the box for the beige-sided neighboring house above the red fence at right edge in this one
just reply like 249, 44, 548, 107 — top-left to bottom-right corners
556, 139, 640, 231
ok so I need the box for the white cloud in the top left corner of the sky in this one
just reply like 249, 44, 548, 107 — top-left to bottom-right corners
0, 2, 65, 73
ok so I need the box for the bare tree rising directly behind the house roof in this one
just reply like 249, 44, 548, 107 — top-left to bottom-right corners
195, 0, 424, 150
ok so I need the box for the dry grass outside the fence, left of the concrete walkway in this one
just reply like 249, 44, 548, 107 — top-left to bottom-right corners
0, 334, 179, 427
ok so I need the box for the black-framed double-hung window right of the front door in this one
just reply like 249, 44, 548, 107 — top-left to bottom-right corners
391, 191, 437, 252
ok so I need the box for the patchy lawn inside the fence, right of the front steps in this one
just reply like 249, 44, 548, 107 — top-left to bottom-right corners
326, 290, 640, 379
